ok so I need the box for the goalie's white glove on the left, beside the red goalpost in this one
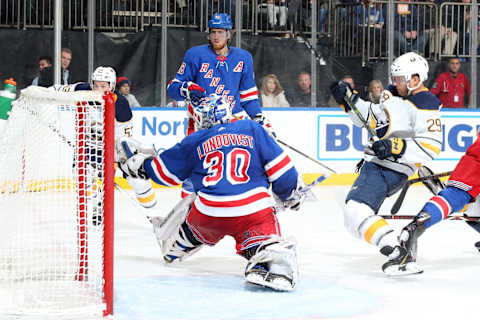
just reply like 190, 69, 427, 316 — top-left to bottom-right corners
116, 138, 157, 180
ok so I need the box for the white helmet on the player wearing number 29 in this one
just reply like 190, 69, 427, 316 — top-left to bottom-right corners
390, 52, 429, 91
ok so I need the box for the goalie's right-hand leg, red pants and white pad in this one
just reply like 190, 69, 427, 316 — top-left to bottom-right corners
231, 208, 298, 291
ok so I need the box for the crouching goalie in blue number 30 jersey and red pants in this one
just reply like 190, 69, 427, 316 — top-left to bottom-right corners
116, 95, 304, 291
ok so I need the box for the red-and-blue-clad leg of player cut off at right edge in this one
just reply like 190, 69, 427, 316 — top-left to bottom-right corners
397, 132, 480, 267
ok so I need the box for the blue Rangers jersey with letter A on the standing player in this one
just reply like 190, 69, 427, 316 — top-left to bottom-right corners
168, 44, 262, 118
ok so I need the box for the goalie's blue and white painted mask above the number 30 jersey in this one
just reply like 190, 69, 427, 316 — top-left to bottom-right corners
193, 94, 232, 129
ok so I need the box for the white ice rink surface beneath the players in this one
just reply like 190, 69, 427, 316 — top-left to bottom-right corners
114, 186, 480, 320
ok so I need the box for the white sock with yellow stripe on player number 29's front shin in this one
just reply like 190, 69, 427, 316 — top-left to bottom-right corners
344, 200, 397, 248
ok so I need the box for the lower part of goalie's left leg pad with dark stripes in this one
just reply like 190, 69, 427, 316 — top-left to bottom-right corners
162, 222, 203, 263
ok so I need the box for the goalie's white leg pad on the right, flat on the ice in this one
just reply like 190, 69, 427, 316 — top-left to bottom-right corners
245, 236, 298, 291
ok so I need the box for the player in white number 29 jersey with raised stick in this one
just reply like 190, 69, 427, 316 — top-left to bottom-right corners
331, 52, 442, 274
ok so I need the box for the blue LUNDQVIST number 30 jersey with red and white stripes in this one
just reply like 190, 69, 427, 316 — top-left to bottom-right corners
144, 119, 298, 217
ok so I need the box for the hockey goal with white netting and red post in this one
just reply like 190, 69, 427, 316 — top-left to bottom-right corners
0, 86, 114, 319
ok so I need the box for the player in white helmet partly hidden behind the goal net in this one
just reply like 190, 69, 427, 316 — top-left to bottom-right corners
53, 67, 157, 215
